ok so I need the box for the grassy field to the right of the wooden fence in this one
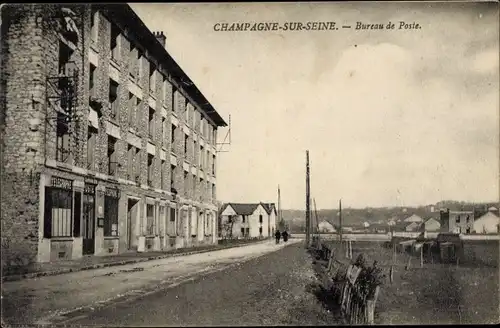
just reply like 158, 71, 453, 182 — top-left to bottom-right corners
322, 242, 499, 324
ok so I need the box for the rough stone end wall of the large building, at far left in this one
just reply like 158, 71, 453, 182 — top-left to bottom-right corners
0, 5, 45, 273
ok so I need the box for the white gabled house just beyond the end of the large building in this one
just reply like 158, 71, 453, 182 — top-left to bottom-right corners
220, 202, 277, 238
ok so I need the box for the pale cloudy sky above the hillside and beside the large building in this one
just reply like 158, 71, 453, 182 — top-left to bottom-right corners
131, 2, 500, 209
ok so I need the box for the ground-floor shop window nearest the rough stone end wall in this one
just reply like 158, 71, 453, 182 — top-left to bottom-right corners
44, 178, 73, 238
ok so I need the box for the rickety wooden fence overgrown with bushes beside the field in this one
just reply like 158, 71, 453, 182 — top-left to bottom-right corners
312, 238, 380, 325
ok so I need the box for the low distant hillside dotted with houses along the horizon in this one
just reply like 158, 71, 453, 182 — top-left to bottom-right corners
282, 201, 499, 231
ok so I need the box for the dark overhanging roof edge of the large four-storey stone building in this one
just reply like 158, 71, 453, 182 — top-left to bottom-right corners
96, 3, 227, 126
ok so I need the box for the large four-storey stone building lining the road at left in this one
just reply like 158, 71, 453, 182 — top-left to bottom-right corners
0, 4, 226, 262
